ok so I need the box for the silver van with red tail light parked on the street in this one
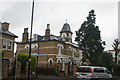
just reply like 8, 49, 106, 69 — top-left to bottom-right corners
75, 66, 112, 80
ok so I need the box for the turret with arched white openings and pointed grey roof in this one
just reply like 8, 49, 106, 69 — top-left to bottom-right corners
60, 23, 73, 42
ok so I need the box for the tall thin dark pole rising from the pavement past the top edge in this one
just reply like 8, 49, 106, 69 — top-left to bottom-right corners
28, 0, 34, 80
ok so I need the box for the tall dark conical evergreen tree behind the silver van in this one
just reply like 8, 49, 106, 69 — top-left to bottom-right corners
75, 10, 105, 65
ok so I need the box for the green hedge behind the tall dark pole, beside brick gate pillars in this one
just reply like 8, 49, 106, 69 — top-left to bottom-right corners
18, 53, 36, 72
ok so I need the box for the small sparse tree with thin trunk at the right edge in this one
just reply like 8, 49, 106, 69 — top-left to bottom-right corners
112, 39, 120, 64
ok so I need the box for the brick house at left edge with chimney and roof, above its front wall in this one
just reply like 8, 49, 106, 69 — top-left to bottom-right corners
0, 22, 18, 59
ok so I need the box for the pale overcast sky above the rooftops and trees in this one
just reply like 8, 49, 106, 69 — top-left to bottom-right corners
0, 0, 118, 50
